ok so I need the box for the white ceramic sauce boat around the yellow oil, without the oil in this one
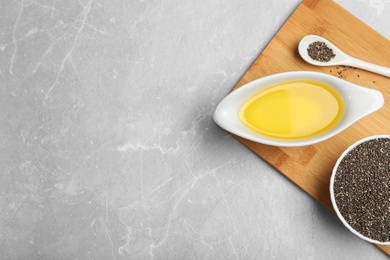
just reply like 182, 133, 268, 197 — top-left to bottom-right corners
213, 71, 384, 147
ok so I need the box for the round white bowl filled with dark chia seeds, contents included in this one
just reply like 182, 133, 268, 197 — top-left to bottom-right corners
330, 135, 390, 245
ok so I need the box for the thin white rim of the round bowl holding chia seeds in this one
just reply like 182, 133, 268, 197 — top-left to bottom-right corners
329, 135, 390, 245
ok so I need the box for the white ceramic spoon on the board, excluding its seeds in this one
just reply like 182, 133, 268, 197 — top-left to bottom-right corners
298, 35, 390, 77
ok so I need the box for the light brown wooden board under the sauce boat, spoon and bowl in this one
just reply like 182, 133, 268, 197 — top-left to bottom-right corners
230, 0, 390, 255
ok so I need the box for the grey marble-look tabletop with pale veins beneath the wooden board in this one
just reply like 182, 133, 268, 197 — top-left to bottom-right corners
0, 0, 390, 260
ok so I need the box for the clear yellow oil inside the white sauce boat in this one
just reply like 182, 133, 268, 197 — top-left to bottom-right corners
239, 80, 344, 139
